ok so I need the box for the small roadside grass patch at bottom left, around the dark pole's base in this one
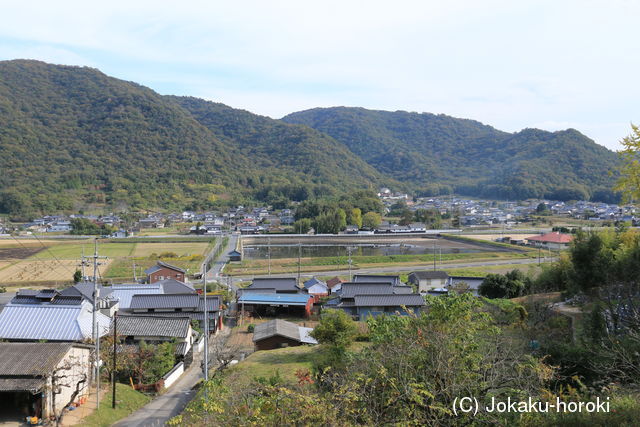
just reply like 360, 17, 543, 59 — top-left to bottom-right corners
82, 384, 151, 427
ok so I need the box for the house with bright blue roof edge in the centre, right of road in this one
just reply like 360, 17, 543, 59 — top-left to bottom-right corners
238, 289, 313, 317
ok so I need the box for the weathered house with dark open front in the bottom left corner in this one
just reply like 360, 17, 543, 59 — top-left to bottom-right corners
0, 342, 92, 425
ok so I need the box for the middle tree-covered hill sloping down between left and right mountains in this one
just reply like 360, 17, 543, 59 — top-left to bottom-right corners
166, 96, 388, 211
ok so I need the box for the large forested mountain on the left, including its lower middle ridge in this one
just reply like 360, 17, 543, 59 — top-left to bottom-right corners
0, 60, 381, 217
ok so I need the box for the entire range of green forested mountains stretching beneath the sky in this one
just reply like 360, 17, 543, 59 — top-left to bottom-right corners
0, 60, 617, 215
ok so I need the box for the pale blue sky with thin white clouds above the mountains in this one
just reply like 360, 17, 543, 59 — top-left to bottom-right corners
0, 0, 640, 150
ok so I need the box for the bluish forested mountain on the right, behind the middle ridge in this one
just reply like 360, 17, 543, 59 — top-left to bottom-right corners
282, 107, 618, 201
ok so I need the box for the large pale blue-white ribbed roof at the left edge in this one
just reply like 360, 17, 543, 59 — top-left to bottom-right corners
0, 301, 110, 341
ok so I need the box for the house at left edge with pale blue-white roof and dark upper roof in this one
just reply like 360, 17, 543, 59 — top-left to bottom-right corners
0, 289, 111, 342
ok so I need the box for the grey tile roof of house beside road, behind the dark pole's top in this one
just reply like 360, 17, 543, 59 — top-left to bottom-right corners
116, 315, 191, 338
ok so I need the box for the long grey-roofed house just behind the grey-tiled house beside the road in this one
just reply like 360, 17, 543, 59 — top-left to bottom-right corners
124, 294, 223, 333
